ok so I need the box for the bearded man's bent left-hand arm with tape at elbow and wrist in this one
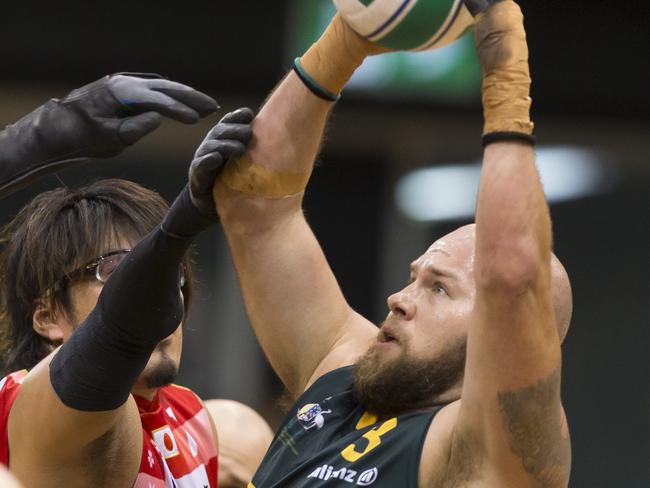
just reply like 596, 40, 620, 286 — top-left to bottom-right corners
215, 17, 388, 394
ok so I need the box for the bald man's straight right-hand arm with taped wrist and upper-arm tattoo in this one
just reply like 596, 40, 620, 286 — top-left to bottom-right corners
452, 0, 570, 487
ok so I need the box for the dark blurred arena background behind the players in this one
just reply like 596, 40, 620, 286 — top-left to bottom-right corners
0, 0, 650, 488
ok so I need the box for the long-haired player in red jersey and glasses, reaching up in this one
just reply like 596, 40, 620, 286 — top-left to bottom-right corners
0, 107, 250, 488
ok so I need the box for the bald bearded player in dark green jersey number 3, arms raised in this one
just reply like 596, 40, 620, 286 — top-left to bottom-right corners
210, 0, 571, 488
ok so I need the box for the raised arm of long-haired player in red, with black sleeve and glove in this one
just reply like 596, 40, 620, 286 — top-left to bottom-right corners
8, 119, 243, 486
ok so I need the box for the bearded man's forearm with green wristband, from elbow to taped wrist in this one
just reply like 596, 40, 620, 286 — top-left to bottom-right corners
217, 15, 384, 206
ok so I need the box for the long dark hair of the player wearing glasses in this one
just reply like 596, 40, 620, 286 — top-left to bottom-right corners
0, 179, 193, 377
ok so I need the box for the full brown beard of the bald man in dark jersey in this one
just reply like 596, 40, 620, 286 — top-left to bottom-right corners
353, 339, 467, 417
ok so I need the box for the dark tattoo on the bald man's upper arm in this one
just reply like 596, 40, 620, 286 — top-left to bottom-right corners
498, 367, 571, 488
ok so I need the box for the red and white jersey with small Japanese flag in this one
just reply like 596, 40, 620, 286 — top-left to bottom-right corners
0, 371, 217, 488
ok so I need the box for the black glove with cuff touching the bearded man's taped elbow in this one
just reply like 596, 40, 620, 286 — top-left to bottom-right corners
162, 108, 255, 237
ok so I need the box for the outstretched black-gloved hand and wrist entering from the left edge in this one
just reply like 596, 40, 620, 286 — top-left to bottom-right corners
0, 73, 218, 198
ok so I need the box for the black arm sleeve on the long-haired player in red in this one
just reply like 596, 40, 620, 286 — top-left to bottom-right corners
50, 187, 213, 411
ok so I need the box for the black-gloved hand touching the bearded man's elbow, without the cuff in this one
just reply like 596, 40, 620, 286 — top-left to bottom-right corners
189, 108, 255, 216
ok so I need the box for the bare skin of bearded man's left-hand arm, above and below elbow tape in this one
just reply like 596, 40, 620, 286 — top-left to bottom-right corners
216, 73, 375, 394
